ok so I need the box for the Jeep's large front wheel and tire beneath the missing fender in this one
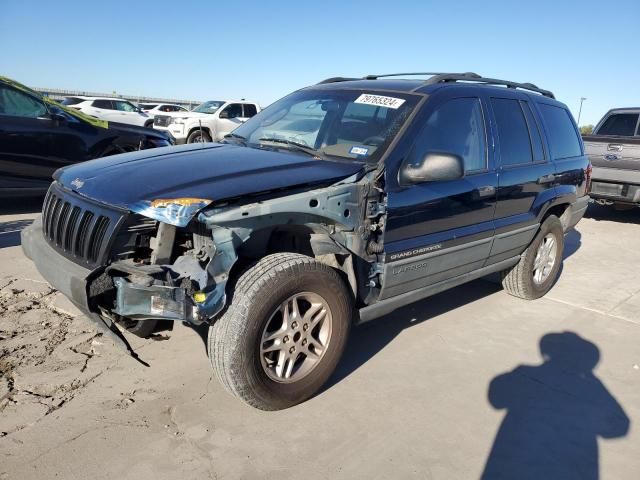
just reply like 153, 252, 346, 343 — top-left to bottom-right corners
208, 253, 353, 410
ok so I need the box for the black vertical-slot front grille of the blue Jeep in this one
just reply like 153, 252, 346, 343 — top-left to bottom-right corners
42, 183, 124, 266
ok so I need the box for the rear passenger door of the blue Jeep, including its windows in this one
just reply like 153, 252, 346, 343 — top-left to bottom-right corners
488, 91, 556, 263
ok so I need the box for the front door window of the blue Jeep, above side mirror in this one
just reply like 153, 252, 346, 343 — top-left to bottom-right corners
415, 98, 487, 172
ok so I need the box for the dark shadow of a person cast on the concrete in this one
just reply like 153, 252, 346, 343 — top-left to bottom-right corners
482, 332, 629, 480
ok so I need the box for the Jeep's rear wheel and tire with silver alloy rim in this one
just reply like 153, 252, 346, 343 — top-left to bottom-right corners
502, 215, 564, 300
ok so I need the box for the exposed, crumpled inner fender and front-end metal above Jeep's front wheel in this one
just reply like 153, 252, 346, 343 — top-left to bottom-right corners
110, 172, 369, 325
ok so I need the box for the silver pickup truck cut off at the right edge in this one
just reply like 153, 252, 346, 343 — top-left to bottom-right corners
582, 108, 640, 206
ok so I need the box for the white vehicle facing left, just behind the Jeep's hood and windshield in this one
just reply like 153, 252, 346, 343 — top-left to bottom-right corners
153, 100, 260, 143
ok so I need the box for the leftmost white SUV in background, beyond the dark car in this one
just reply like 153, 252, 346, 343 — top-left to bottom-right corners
62, 97, 153, 127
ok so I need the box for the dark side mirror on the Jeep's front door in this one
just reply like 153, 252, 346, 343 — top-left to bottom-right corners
400, 152, 464, 184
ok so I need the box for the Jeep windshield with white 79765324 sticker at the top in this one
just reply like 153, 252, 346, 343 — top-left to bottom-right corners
230, 90, 419, 162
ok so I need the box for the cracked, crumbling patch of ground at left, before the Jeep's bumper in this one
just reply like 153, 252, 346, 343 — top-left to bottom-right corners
0, 278, 112, 436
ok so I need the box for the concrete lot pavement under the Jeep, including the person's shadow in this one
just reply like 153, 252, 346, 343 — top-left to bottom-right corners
0, 203, 640, 479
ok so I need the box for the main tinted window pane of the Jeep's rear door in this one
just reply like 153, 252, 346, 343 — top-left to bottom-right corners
491, 98, 533, 166
